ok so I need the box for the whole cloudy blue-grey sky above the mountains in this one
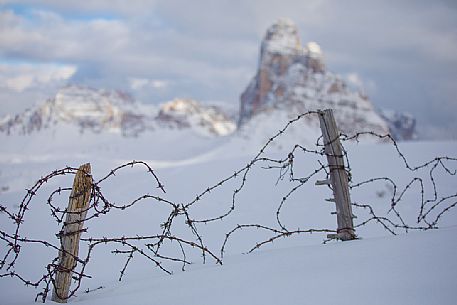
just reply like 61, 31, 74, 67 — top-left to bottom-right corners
0, 0, 457, 138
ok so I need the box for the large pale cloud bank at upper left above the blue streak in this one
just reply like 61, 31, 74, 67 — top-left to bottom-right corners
0, 10, 132, 62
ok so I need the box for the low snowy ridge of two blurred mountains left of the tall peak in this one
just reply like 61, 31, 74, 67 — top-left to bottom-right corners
0, 85, 236, 136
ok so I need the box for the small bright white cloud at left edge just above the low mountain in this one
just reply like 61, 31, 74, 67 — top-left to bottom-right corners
0, 64, 77, 92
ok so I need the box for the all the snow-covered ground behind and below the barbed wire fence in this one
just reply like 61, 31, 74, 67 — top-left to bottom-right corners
0, 125, 457, 305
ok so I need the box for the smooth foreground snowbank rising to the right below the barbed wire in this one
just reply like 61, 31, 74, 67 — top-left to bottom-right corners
49, 227, 457, 305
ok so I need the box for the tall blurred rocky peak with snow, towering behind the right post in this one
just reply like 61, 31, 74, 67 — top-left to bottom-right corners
238, 20, 389, 134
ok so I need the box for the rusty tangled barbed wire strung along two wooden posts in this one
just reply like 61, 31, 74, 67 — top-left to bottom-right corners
0, 111, 457, 302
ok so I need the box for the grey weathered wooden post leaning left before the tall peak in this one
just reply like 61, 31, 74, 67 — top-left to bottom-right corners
316, 109, 356, 241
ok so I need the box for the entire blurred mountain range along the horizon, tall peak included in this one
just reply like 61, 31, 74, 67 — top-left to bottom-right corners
0, 19, 416, 140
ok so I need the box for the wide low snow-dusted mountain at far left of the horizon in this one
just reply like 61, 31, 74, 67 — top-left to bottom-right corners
0, 86, 143, 134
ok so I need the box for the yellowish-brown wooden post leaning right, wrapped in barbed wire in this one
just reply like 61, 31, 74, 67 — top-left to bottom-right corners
52, 163, 92, 303
